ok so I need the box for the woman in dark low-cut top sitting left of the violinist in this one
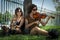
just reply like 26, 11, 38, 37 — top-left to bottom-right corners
10, 8, 24, 33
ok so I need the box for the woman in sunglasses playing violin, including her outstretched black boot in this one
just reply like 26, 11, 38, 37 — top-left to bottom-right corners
25, 4, 58, 38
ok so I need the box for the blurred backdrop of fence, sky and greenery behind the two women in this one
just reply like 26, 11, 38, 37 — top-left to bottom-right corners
0, 0, 60, 27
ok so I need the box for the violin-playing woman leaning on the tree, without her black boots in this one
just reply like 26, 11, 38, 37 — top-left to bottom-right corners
25, 4, 51, 35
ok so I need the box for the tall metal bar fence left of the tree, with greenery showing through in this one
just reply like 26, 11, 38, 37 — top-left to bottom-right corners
0, 0, 23, 24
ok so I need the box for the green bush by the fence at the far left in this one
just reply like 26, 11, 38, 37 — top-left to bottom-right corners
0, 11, 12, 24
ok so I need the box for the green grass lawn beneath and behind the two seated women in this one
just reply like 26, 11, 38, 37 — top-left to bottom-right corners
0, 26, 60, 40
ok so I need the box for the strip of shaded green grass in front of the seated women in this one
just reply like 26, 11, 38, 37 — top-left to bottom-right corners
0, 35, 44, 40
